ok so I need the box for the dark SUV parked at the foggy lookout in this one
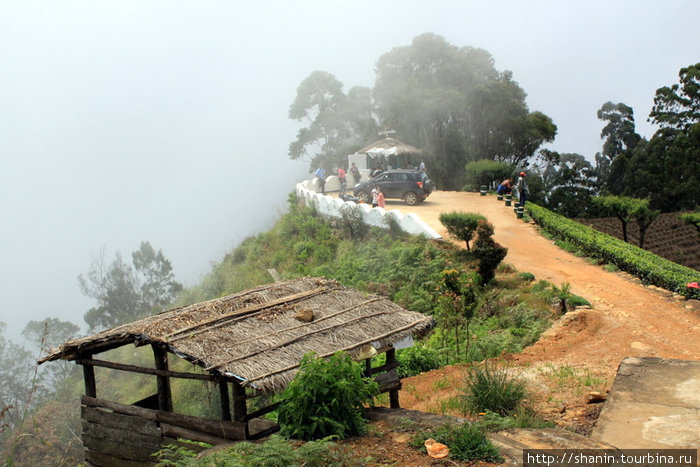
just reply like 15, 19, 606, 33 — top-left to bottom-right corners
353, 169, 433, 206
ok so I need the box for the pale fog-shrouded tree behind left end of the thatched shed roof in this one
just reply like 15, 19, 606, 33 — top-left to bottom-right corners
78, 242, 182, 332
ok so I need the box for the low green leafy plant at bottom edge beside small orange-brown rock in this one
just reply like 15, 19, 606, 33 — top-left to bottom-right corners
410, 423, 503, 462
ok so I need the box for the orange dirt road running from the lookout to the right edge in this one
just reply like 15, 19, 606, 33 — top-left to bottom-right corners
387, 191, 700, 409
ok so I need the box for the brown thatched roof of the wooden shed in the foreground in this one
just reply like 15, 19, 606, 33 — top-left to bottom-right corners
40, 277, 435, 392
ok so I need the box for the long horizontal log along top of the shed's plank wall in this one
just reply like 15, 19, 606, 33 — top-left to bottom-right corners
81, 396, 247, 439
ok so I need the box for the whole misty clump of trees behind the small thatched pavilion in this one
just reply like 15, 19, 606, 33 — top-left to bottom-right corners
289, 33, 557, 189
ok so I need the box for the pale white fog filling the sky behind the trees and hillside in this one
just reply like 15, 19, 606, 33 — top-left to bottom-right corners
0, 0, 700, 340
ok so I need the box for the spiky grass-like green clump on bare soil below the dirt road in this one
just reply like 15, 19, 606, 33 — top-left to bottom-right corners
461, 364, 527, 416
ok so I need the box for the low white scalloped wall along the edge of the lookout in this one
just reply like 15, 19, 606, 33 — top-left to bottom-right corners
297, 176, 442, 239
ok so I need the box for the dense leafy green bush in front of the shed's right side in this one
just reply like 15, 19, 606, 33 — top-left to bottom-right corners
277, 352, 379, 440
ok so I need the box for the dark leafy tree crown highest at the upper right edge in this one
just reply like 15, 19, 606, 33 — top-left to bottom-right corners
649, 63, 700, 130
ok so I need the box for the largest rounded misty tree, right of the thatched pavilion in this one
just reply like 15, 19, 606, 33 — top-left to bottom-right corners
373, 33, 556, 189
